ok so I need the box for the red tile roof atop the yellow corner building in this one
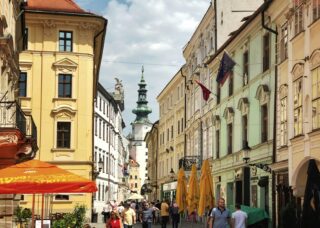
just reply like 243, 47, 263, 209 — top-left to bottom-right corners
26, 0, 88, 13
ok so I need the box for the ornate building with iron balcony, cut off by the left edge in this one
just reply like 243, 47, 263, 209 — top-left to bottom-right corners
0, 0, 38, 227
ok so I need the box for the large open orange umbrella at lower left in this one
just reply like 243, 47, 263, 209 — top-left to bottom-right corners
0, 160, 97, 194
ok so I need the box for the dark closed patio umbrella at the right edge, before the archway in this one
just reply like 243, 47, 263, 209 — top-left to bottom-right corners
302, 159, 320, 228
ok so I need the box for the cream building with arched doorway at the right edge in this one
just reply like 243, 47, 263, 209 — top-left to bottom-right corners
270, 0, 320, 225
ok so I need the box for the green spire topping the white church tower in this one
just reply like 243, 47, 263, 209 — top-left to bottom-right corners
132, 66, 152, 123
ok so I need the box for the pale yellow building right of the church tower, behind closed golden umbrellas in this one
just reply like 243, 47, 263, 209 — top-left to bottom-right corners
157, 66, 185, 199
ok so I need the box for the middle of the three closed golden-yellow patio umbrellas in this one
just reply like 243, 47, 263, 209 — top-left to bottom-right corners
187, 164, 199, 214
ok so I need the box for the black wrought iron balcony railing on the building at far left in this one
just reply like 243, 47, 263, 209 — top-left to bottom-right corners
0, 101, 38, 150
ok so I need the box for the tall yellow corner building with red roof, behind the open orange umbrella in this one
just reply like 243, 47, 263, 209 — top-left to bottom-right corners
20, 0, 107, 216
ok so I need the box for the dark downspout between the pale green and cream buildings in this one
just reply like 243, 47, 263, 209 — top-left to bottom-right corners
261, 0, 278, 227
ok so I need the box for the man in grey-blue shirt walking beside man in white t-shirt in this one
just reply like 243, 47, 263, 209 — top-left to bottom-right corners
209, 198, 231, 228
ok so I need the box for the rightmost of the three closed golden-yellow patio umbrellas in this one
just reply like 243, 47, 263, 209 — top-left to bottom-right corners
198, 160, 214, 216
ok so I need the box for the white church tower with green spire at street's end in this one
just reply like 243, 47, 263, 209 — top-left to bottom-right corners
129, 66, 152, 186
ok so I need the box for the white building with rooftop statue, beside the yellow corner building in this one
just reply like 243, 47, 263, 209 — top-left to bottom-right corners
94, 82, 128, 221
